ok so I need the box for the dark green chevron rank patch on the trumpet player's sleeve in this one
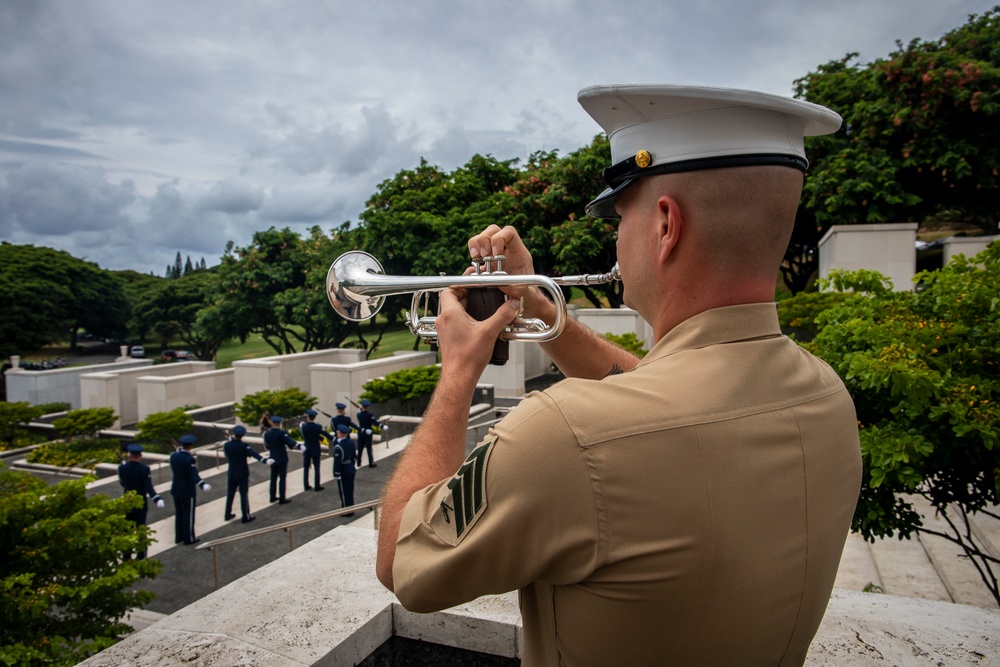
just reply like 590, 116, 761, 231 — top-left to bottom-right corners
431, 437, 496, 545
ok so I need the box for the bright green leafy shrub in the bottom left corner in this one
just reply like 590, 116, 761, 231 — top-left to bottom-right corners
0, 466, 162, 667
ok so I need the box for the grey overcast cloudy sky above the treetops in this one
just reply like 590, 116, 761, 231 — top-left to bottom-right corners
0, 0, 996, 275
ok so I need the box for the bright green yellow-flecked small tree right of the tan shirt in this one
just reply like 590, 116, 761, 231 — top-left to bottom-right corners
796, 242, 1000, 603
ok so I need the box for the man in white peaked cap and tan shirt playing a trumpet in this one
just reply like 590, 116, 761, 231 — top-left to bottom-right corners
376, 85, 861, 667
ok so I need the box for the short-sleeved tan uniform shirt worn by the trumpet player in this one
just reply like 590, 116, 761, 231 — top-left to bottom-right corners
393, 304, 861, 667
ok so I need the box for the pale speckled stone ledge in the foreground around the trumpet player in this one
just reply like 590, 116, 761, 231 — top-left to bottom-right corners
81, 526, 1000, 667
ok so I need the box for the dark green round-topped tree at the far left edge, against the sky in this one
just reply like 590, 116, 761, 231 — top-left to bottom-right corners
0, 242, 128, 356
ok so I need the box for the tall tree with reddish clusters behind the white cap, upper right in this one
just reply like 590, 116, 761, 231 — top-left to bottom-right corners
783, 7, 1000, 293
